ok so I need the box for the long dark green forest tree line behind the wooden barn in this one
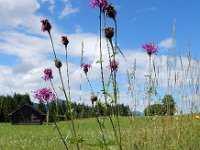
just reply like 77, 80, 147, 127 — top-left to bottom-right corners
0, 94, 131, 122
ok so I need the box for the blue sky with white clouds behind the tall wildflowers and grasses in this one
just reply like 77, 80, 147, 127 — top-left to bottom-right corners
0, 0, 200, 112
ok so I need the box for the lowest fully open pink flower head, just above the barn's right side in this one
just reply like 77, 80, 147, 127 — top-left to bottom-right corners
34, 88, 56, 104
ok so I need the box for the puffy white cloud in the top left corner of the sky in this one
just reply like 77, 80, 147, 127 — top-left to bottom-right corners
0, 0, 40, 32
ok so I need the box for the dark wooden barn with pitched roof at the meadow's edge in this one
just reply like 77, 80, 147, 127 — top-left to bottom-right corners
9, 103, 45, 124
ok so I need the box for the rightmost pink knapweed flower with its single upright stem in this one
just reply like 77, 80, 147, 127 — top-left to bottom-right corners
142, 43, 159, 115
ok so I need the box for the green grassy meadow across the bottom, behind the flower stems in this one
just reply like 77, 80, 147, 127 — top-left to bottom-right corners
0, 116, 200, 150
